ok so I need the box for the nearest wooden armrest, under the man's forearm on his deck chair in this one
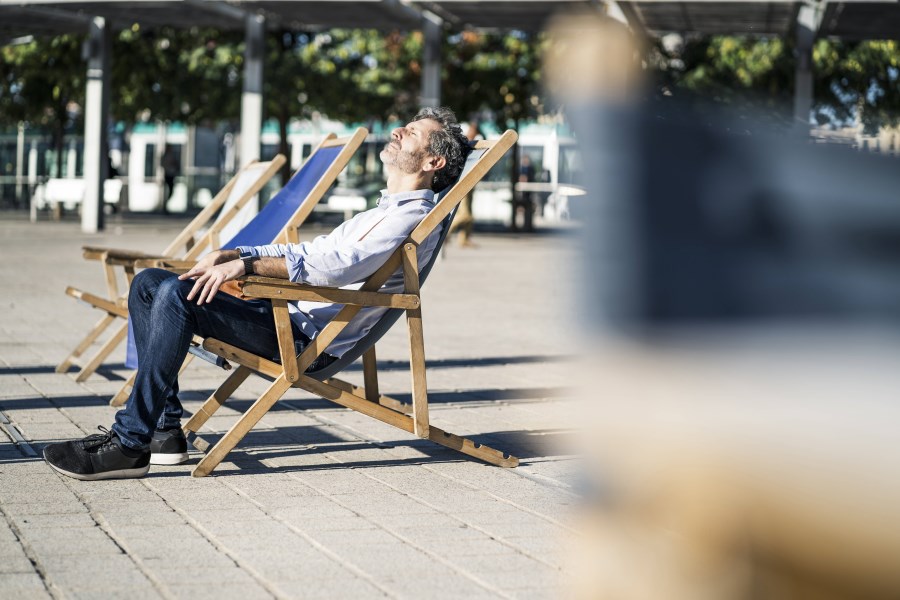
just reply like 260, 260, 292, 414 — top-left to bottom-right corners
240, 276, 420, 309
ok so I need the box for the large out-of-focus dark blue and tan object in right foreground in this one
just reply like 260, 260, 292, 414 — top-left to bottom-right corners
546, 10, 900, 600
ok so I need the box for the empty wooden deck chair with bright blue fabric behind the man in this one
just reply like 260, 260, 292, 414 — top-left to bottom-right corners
110, 127, 369, 406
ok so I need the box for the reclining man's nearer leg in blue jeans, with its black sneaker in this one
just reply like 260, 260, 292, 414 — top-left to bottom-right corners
44, 269, 290, 480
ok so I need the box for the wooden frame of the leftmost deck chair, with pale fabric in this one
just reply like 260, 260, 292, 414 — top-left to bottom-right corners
56, 154, 285, 382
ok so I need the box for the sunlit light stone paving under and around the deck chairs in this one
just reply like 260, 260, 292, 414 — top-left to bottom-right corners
0, 213, 578, 600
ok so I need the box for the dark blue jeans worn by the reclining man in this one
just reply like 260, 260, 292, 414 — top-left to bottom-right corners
112, 269, 333, 449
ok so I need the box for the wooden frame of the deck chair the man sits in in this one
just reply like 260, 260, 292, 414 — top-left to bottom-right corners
184, 131, 519, 477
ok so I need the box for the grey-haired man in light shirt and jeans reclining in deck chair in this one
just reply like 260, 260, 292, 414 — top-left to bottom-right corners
44, 108, 469, 480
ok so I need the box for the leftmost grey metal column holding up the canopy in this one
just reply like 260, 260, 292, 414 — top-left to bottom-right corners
81, 17, 112, 233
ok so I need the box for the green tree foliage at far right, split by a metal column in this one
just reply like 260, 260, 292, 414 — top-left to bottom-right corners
648, 36, 900, 131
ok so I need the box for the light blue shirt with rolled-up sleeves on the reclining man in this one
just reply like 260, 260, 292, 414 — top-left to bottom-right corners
238, 190, 441, 356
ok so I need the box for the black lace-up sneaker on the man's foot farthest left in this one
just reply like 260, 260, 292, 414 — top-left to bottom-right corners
44, 427, 150, 481
